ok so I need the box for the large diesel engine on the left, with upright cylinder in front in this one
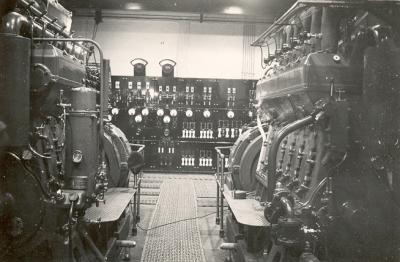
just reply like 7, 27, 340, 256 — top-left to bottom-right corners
0, 0, 140, 262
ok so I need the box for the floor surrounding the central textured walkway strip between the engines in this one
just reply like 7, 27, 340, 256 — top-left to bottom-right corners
128, 174, 226, 262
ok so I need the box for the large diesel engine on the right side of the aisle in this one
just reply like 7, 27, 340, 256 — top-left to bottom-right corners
219, 0, 400, 262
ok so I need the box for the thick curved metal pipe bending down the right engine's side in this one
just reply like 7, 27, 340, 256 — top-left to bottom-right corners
267, 115, 315, 202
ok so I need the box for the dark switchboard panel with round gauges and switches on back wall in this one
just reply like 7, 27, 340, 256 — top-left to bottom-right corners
109, 76, 256, 172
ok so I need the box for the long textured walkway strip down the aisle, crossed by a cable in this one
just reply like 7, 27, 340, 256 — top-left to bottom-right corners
141, 179, 205, 262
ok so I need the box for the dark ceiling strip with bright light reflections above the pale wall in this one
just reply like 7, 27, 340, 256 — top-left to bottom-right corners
59, 0, 295, 18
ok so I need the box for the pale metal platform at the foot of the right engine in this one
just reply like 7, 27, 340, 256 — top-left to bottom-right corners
223, 185, 270, 227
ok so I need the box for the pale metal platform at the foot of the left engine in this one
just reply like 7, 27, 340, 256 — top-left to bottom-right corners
85, 187, 136, 223
